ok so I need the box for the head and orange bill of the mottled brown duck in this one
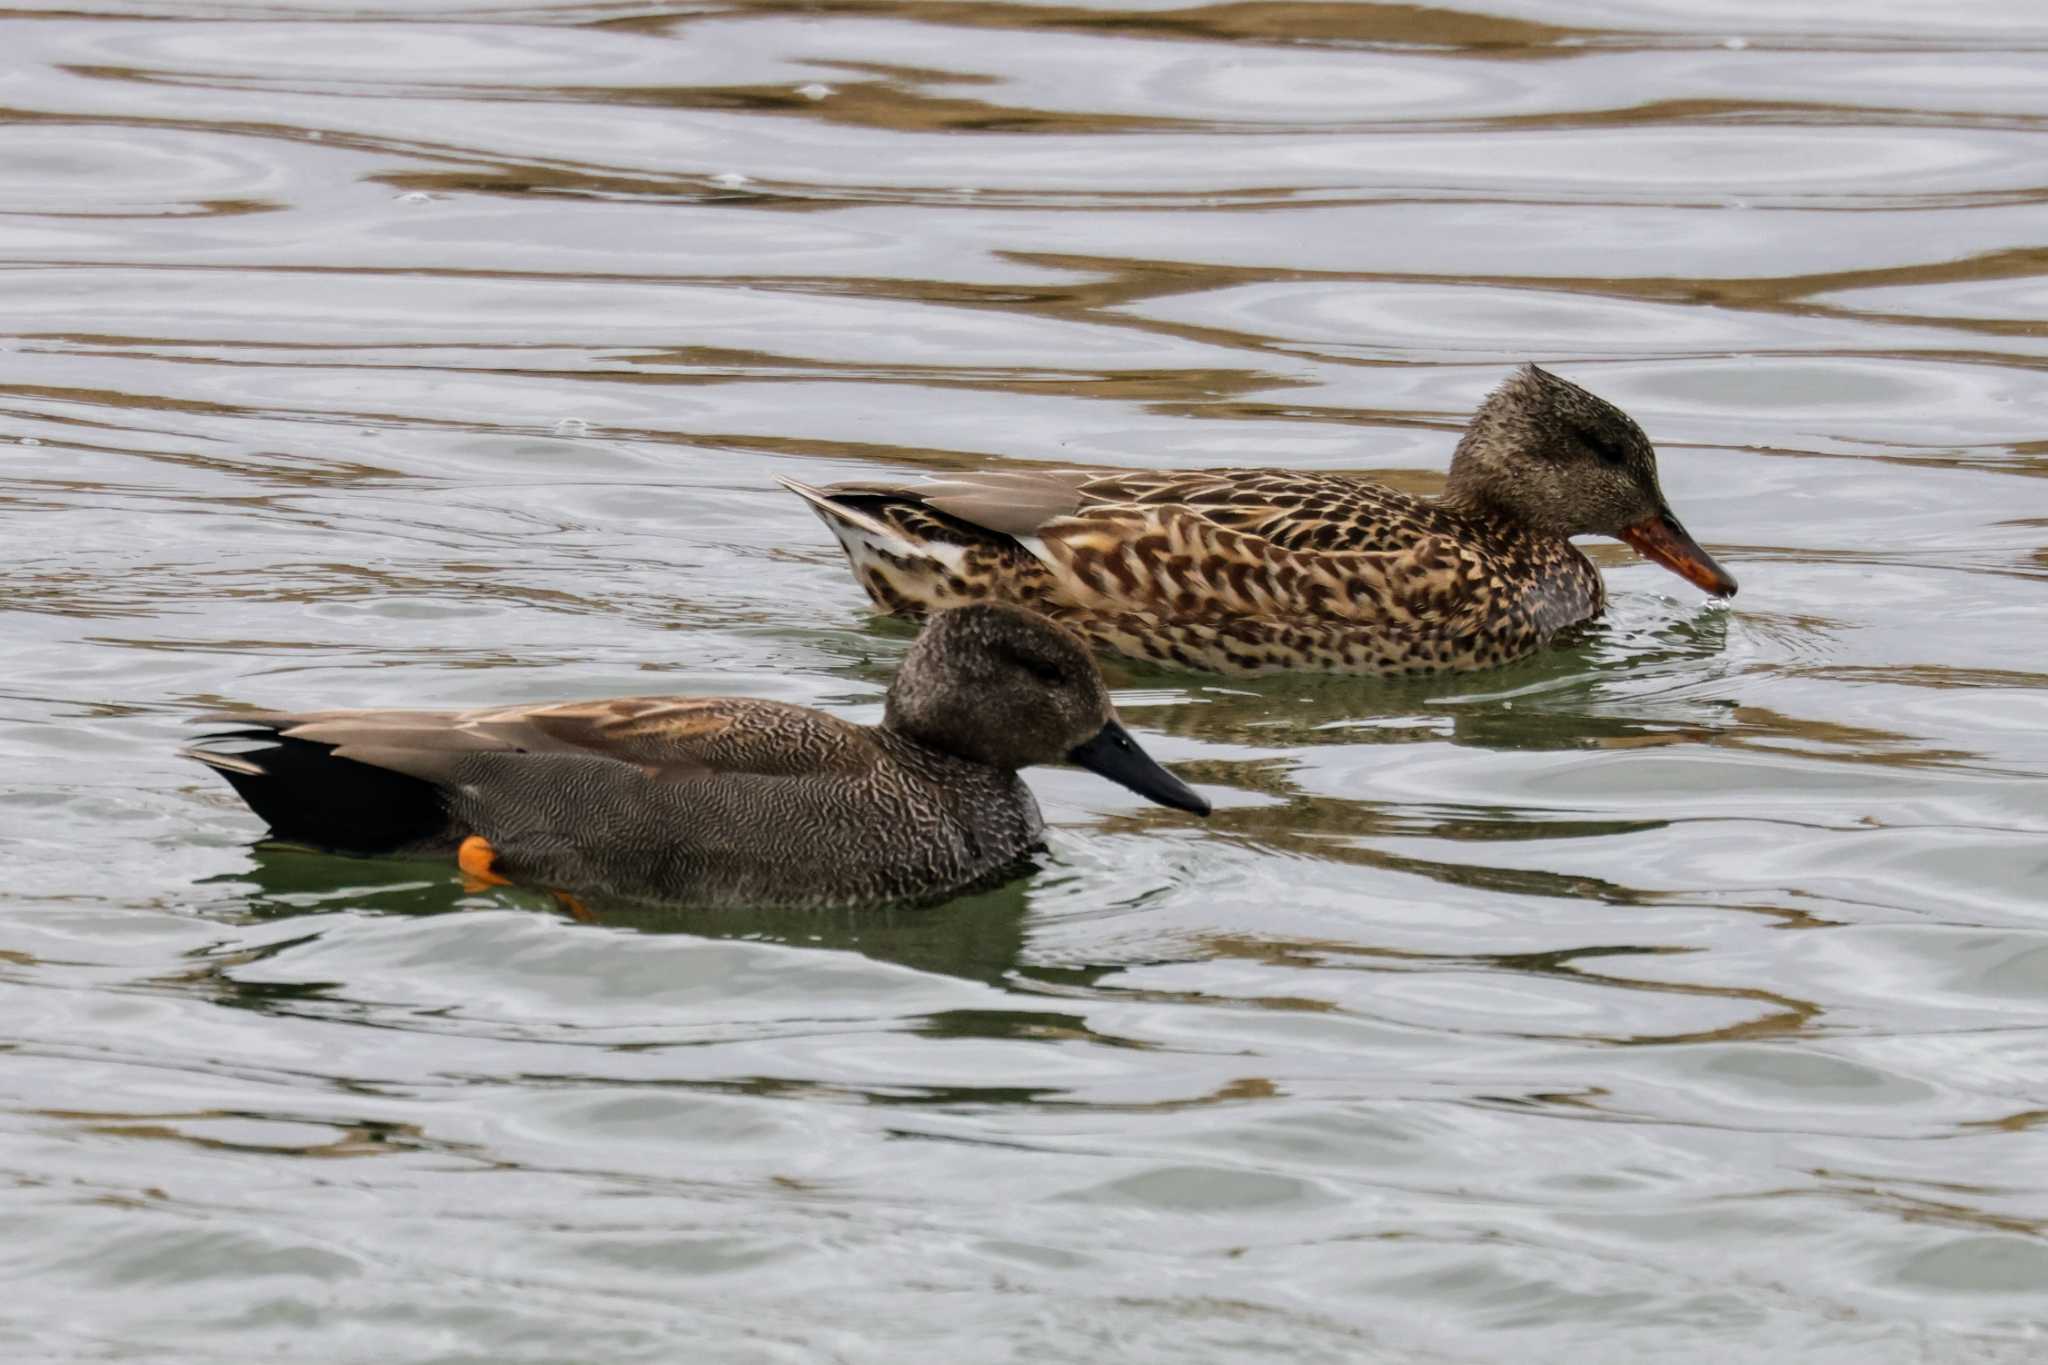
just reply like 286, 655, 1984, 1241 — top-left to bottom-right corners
1448, 364, 1735, 598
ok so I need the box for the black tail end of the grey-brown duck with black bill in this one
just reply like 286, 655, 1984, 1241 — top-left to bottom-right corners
186, 729, 451, 853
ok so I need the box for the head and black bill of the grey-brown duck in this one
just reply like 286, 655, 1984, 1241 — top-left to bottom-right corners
883, 602, 1208, 814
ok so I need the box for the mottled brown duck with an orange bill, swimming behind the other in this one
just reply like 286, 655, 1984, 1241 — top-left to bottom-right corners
780, 364, 1737, 677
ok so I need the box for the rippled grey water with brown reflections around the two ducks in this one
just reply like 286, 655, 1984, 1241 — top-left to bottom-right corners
0, 0, 2048, 1363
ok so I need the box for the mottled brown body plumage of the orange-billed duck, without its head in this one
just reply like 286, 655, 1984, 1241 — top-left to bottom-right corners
782, 469, 1604, 673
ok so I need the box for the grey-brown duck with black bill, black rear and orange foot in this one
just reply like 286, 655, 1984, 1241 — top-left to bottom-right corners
184, 602, 1210, 917
